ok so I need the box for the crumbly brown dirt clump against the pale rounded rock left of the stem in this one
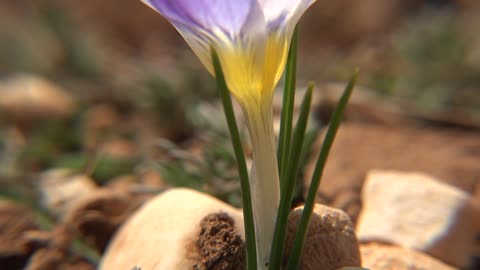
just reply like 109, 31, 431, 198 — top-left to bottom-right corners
194, 213, 246, 270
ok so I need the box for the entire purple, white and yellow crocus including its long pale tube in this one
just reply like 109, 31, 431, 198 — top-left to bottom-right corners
142, 0, 315, 269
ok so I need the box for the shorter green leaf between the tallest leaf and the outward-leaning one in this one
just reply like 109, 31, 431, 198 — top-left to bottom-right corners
269, 85, 313, 270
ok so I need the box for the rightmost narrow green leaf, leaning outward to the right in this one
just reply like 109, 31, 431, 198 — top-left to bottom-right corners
286, 71, 358, 270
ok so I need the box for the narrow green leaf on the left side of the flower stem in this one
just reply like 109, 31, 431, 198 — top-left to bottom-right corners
212, 48, 257, 270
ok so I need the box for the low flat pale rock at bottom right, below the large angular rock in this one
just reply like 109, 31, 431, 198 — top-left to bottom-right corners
360, 244, 456, 270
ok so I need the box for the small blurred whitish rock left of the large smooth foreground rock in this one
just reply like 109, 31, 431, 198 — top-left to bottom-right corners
37, 169, 96, 216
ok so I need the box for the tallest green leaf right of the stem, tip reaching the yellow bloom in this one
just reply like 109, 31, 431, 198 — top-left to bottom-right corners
277, 28, 298, 188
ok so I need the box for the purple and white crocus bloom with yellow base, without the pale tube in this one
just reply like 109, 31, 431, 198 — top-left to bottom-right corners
142, 0, 315, 103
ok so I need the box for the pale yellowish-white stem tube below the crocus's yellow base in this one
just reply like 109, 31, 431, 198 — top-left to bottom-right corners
242, 98, 280, 270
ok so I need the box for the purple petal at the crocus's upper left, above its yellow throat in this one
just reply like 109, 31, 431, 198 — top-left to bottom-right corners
143, 0, 254, 37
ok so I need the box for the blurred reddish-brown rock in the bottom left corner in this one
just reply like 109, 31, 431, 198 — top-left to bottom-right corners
0, 200, 38, 269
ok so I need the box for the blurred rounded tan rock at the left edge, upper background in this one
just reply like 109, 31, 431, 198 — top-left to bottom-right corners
0, 74, 75, 120
